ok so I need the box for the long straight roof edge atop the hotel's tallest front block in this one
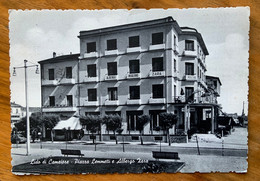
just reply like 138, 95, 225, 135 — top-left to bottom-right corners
78, 16, 181, 38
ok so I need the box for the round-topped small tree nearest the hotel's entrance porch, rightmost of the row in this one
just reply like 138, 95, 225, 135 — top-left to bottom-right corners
159, 112, 178, 146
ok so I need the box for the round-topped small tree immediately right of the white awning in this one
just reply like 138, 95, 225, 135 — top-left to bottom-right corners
80, 115, 102, 144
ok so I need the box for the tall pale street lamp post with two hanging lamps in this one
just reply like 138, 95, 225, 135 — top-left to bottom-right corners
13, 60, 39, 156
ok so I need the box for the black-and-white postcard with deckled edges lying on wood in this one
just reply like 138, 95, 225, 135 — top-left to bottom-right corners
9, 7, 250, 175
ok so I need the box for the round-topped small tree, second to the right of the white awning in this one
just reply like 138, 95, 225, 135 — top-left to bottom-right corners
103, 114, 122, 144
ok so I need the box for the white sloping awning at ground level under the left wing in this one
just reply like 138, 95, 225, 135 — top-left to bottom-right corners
53, 116, 82, 130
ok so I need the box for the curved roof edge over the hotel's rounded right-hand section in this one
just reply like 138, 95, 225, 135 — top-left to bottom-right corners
181, 27, 209, 55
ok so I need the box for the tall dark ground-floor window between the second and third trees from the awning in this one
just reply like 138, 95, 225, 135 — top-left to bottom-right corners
126, 111, 143, 131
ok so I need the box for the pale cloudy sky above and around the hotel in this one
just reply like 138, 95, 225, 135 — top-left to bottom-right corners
9, 7, 250, 114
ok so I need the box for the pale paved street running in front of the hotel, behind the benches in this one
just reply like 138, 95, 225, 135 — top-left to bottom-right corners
12, 128, 247, 172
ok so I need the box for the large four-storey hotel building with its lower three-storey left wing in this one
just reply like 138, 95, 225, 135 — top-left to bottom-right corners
39, 17, 221, 141
